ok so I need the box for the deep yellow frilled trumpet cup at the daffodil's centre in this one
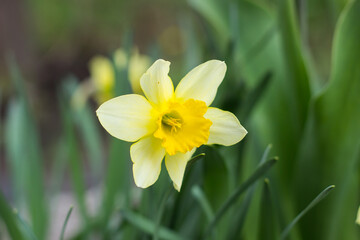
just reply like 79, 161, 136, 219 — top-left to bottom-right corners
154, 99, 212, 155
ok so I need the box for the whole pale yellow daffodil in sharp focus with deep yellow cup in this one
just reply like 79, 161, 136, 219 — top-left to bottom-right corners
96, 59, 247, 191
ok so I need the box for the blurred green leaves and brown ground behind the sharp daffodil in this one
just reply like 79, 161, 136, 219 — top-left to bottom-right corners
0, 0, 360, 240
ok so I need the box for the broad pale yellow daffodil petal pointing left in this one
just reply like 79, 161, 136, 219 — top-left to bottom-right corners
96, 94, 156, 142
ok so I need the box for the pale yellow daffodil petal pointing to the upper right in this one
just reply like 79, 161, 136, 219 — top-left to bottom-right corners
175, 60, 226, 106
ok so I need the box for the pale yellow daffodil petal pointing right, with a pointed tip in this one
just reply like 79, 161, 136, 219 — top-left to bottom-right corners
204, 107, 247, 146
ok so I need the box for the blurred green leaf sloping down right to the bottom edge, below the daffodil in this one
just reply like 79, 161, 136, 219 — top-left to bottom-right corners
121, 210, 185, 240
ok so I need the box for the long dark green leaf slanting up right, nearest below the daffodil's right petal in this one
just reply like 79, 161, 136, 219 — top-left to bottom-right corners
204, 158, 277, 237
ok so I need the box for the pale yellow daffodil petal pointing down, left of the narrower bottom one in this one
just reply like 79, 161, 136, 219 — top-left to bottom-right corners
130, 135, 165, 188
